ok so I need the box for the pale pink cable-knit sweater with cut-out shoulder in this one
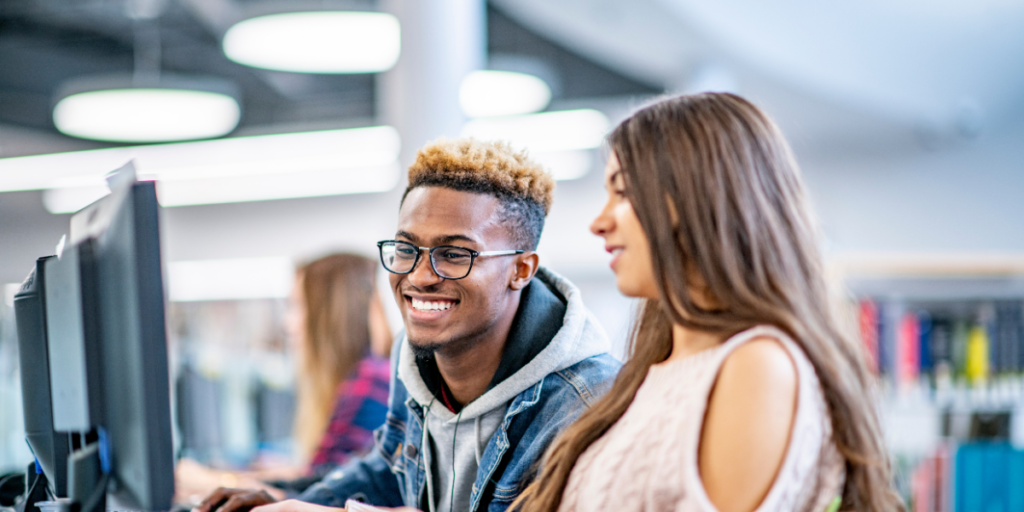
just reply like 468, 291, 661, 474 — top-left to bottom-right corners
559, 326, 846, 512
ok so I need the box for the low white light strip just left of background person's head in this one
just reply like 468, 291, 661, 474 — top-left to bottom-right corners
167, 257, 295, 302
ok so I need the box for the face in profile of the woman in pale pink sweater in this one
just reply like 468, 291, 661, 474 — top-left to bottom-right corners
590, 153, 658, 299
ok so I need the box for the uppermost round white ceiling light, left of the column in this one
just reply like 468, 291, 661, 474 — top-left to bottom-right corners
223, 11, 401, 74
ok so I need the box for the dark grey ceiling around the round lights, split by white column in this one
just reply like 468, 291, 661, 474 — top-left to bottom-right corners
0, 0, 663, 157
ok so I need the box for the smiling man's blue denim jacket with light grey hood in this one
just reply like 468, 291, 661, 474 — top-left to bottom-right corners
299, 267, 620, 512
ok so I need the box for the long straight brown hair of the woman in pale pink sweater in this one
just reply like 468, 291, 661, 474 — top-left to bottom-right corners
513, 93, 903, 512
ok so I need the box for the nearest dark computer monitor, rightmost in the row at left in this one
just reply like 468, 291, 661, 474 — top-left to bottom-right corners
72, 181, 174, 510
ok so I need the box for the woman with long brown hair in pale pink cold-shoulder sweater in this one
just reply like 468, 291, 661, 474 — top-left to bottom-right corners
513, 93, 902, 512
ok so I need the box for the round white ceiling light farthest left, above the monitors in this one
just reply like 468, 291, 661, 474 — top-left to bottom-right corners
53, 78, 242, 142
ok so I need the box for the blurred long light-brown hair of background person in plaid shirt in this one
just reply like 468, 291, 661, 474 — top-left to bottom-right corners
293, 254, 377, 459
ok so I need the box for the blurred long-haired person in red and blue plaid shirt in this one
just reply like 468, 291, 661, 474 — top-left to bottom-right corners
176, 254, 391, 503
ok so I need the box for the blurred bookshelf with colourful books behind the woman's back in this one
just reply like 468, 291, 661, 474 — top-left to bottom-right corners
833, 254, 1024, 512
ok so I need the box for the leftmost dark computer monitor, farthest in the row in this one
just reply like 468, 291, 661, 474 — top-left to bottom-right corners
14, 256, 70, 497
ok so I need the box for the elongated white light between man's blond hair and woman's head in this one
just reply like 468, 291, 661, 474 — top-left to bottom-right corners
462, 110, 611, 154
